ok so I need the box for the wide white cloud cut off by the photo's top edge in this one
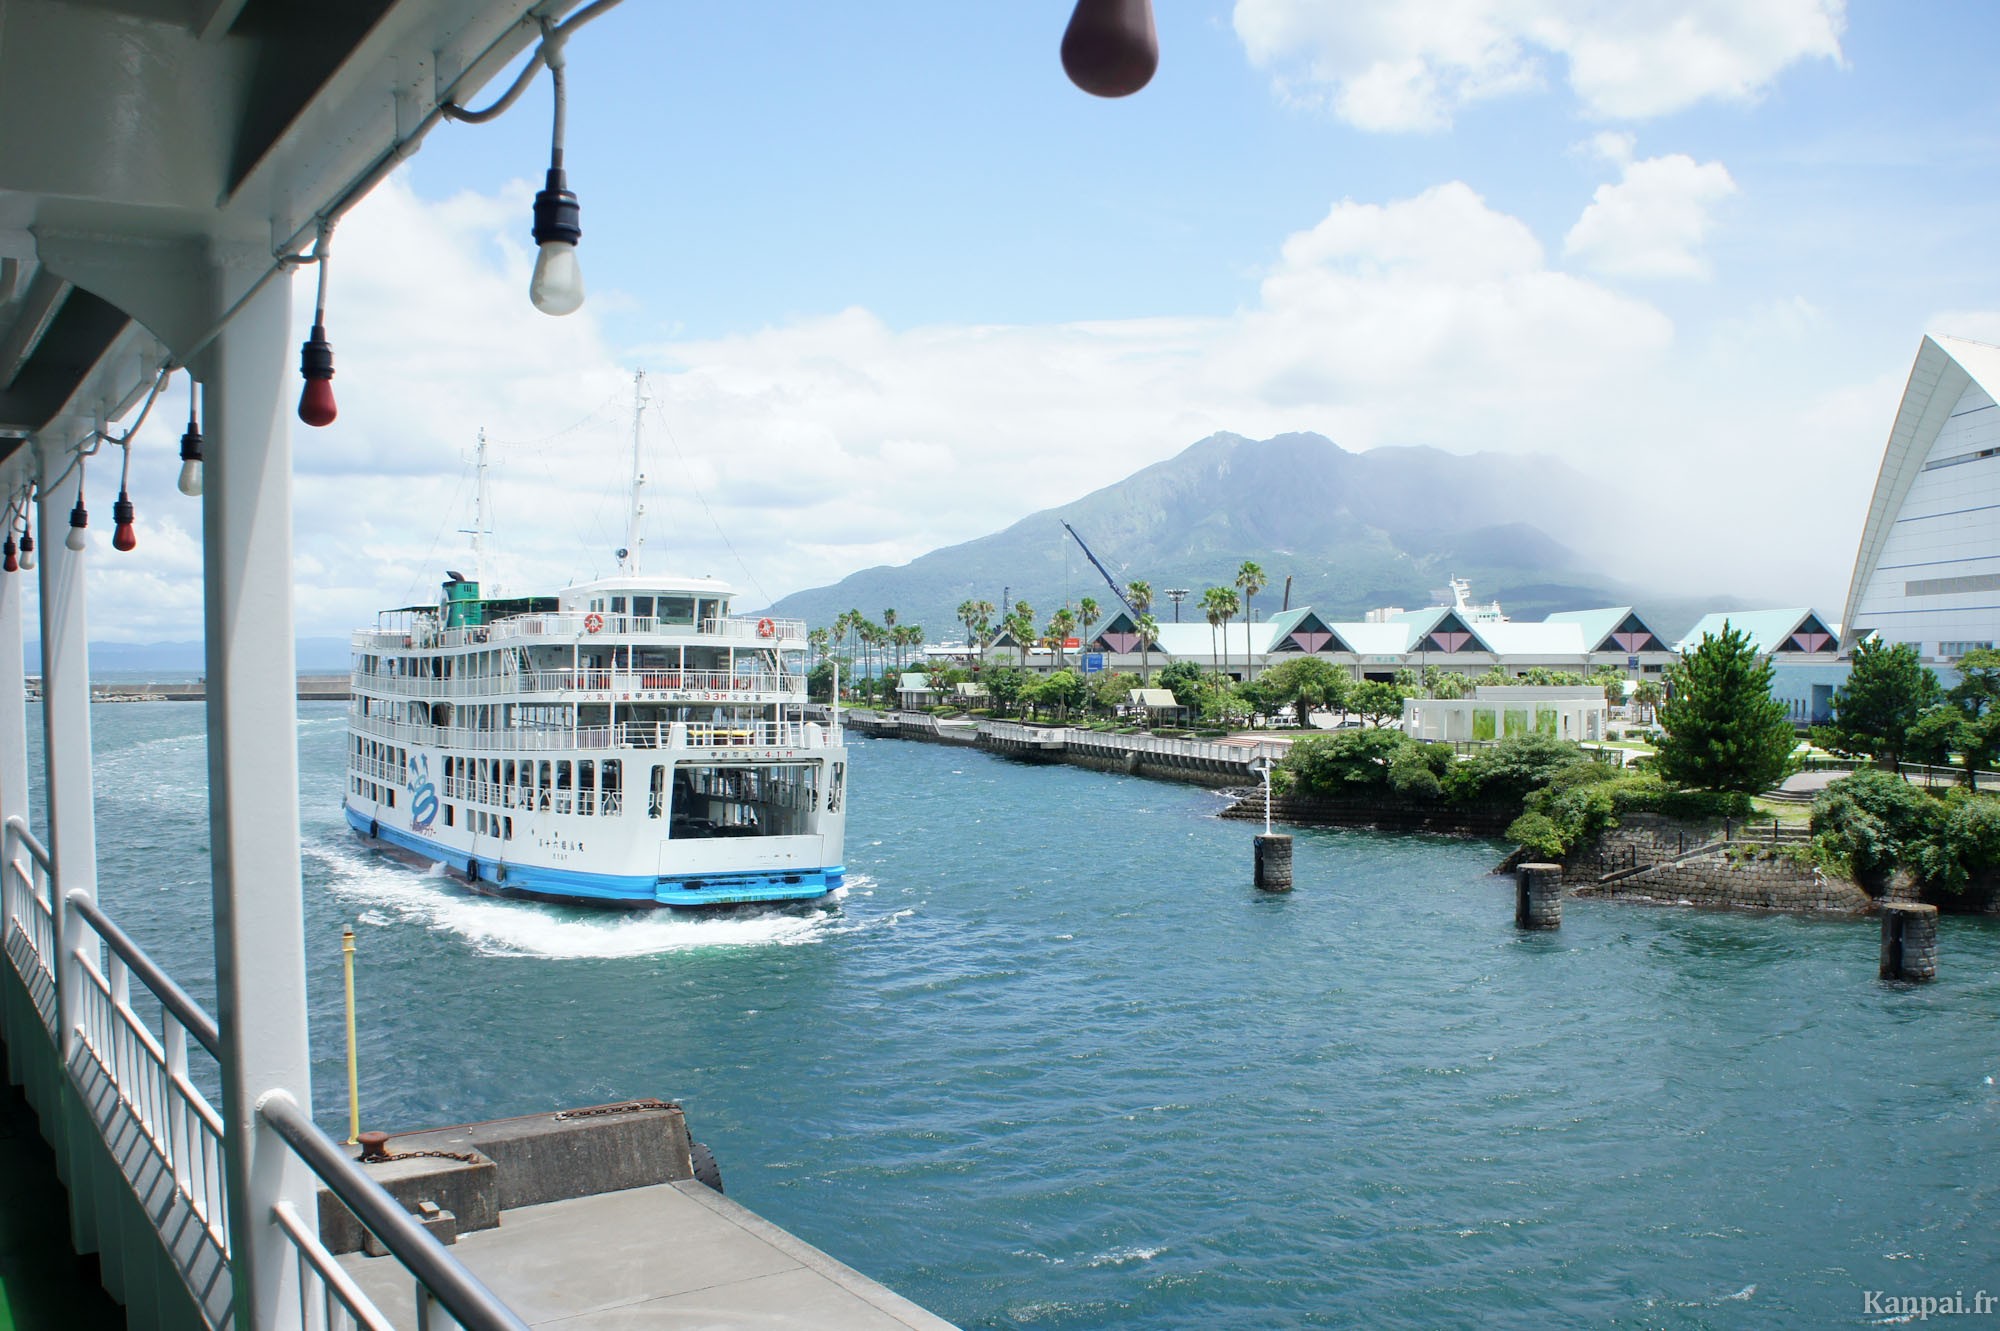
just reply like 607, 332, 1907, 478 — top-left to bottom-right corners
1236, 0, 1846, 130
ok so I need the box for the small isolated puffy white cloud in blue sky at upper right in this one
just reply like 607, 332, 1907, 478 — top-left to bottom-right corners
1562, 147, 1736, 278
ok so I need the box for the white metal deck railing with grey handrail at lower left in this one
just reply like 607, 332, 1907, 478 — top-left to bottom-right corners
0, 817, 526, 1331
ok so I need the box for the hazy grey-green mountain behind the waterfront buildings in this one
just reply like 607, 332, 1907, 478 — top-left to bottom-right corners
770, 425, 1680, 642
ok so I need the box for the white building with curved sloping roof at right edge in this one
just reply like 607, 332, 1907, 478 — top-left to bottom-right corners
1840, 336, 2000, 666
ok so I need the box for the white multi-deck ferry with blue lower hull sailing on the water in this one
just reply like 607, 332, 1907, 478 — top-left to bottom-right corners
346, 574, 846, 907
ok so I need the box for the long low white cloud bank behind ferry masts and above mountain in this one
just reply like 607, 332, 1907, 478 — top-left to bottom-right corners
62, 168, 1894, 642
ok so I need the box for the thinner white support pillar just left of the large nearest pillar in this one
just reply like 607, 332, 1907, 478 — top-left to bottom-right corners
36, 444, 98, 1061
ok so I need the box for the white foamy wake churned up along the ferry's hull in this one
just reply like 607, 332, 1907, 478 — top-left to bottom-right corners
312, 845, 866, 961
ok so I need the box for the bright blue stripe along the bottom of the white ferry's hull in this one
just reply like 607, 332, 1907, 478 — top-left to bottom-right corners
342, 805, 846, 907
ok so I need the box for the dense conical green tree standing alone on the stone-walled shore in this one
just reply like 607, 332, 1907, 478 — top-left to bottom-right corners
1654, 620, 1798, 793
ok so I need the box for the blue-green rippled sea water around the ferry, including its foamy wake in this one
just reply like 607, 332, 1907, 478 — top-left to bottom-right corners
27, 703, 2000, 1329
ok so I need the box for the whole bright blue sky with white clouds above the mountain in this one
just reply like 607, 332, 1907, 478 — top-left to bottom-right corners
70, 0, 2000, 640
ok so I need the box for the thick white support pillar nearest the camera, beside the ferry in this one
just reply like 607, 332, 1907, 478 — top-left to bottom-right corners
196, 261, 318, 1331
